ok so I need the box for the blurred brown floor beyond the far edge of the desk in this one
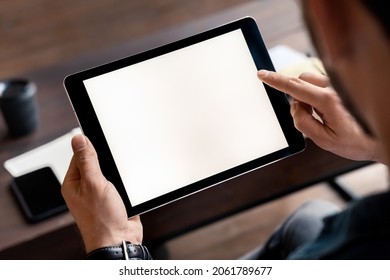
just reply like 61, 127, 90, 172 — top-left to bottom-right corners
0, 0, 250, 78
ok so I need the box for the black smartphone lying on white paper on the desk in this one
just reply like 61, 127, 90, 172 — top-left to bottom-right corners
11, 167, 68, 223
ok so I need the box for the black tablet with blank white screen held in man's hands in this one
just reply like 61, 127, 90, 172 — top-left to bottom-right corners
64, 17, 305, 216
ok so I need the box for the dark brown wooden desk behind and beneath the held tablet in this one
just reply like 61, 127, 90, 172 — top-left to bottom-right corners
0, 0, 368, 259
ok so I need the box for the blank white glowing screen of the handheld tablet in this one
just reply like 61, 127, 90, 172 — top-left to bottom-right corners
84, 30, 288, 206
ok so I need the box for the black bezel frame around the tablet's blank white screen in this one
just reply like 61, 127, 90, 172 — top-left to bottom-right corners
64, 17, 305, 217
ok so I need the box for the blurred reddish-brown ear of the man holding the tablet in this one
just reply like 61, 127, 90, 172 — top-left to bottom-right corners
306, 0, 355, 62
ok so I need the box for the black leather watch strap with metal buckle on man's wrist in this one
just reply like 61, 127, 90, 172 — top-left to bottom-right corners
87, 241, 152, 260
